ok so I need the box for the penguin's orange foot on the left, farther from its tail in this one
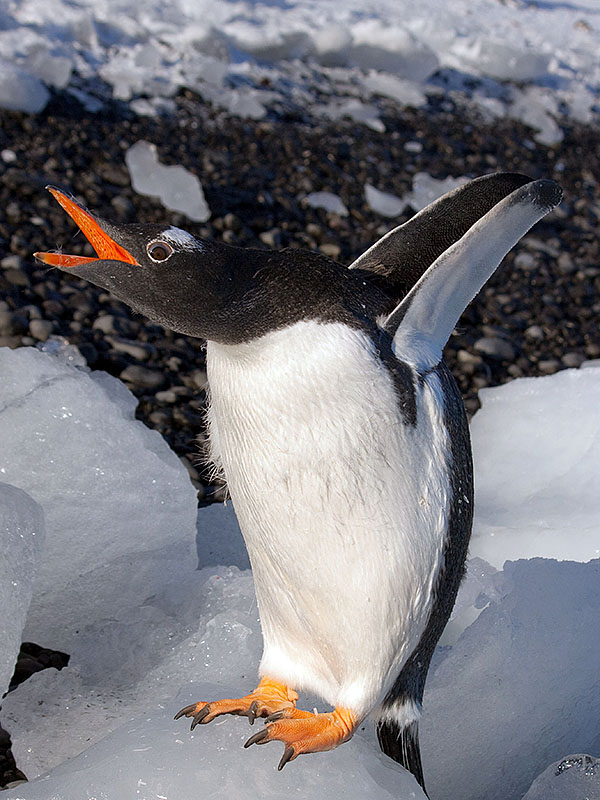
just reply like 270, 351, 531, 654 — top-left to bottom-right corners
175, 678, 298, 730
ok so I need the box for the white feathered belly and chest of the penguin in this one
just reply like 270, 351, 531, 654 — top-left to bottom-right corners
207, 322, 451, 718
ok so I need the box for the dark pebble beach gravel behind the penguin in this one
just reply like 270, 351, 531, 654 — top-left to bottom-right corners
0, 89, 600, 786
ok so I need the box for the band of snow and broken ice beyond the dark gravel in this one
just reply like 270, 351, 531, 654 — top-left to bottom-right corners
0, 0, 600, 144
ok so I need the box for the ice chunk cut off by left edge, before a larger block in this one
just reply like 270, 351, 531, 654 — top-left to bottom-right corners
0, 483, 45, 697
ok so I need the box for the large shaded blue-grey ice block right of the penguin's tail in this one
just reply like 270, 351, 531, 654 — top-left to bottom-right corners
421, 556, 600, 800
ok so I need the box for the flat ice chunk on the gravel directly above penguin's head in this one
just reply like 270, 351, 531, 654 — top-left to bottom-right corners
125, 140, 210, 222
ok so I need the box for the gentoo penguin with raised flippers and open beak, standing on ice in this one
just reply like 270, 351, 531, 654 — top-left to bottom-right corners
35, 174, 561, 786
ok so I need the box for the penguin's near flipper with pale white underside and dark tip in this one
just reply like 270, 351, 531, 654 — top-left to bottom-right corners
381, 180, 562, 371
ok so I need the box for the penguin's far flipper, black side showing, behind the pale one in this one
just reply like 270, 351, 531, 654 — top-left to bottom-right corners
349, 172, 532, 297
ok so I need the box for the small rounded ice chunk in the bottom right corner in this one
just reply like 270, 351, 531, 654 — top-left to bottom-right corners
523, 754, 600, 800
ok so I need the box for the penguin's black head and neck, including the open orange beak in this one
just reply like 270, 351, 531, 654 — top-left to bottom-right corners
34, 186, 386, 344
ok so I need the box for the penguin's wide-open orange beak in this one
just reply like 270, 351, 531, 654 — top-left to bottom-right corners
33, 186, 138, 269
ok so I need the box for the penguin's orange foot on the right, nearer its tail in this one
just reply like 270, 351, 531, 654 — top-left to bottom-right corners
244, 708, 358, 770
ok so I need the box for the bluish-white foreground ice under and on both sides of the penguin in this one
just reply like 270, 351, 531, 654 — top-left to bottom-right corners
0, 341, 600, 800
